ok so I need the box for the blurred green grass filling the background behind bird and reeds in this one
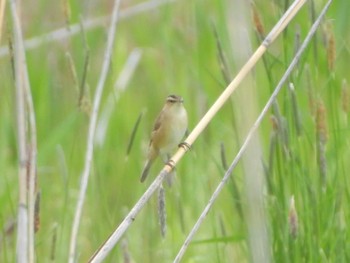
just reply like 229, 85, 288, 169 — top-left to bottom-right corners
0, 0, 350, 262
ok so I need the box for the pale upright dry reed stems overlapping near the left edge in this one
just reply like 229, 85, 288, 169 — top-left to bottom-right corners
10, 1, 37, 262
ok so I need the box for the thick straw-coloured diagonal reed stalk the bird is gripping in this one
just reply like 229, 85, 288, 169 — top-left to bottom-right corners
89, 0, 306, 263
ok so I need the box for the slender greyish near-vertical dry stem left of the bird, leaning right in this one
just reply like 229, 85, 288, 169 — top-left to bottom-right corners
68, 0, 121, 263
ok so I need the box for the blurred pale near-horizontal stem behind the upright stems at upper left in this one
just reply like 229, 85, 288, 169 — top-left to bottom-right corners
0, 0, 175, 58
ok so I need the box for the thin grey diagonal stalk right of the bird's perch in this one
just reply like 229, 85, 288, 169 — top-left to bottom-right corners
174, 0, 332, 263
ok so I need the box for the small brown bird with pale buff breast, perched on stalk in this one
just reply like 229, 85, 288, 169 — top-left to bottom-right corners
140, 95, 187, 182
